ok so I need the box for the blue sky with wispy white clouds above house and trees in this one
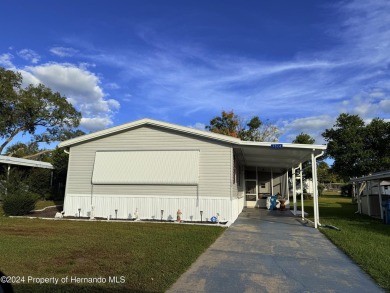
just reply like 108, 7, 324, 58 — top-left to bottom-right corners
0, 0, 390, 143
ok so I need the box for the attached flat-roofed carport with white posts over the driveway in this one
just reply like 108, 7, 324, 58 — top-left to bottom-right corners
235, 141, 326, 228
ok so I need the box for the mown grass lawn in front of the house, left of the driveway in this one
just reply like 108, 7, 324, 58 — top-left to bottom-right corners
0, 216, 224, 292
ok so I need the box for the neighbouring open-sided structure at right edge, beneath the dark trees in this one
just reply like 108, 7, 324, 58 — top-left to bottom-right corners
351, 170, 390, 219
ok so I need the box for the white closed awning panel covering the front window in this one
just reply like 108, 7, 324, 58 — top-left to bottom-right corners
92, 150, 199, 185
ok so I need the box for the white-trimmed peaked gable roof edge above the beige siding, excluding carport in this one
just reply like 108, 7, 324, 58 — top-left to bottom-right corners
58, 118, 241, 147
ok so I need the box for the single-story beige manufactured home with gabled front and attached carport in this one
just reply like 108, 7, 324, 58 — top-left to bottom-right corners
59, 119, 326, 223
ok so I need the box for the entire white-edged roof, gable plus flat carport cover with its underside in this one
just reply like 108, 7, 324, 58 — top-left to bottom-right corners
59, 118, 326, 170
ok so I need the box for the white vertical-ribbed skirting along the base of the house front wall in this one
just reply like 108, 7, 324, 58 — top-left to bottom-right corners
64, 194, 242, 222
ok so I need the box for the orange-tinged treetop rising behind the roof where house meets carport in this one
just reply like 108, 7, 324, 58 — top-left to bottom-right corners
206, 111, 280, 142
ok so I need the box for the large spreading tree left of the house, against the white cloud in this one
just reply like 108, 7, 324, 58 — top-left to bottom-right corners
0, 67, 81, 153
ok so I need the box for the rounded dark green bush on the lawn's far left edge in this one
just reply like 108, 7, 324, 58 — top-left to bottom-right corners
3, 192, 38, 216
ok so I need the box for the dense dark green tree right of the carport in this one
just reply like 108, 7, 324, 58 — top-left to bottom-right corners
322, 113, 390, 180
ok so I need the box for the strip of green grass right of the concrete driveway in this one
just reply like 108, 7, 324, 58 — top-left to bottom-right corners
298, 194, 390, 291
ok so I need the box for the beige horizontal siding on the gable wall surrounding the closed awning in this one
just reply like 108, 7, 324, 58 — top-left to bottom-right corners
66, 126, 231, 197
